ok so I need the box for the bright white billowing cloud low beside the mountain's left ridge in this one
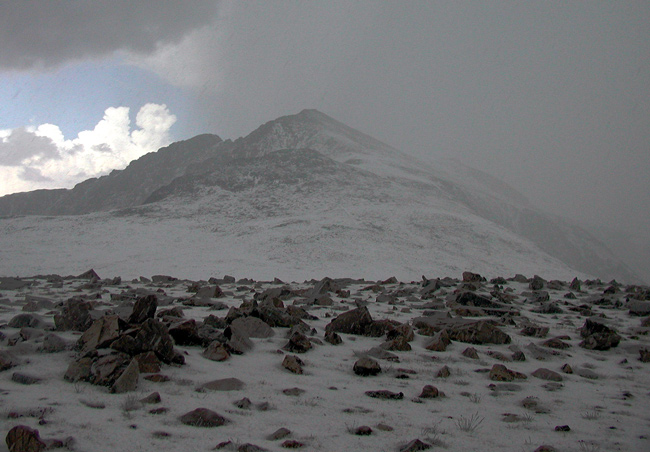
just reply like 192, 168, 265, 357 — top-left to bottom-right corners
0, 103, 176, 196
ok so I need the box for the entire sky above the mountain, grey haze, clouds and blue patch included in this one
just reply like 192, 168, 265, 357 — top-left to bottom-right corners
0, 0, 650, 235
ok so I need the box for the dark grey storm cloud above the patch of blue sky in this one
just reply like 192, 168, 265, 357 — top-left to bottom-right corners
0, 0, 217, 70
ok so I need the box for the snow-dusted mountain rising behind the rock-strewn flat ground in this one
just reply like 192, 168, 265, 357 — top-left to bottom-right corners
0, 110, 637, 281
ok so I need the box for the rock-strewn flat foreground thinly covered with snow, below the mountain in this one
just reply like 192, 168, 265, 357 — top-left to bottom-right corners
0, 270, 650, 452
